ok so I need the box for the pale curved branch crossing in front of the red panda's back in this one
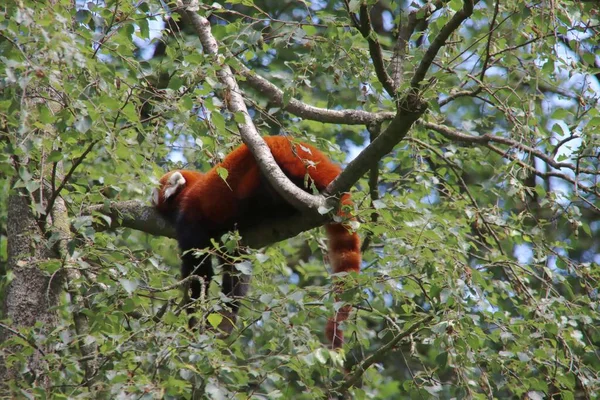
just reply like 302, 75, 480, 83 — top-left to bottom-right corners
177, 0, 326, 211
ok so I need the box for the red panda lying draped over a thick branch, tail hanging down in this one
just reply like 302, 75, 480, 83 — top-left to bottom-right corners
152, 136, 361, 348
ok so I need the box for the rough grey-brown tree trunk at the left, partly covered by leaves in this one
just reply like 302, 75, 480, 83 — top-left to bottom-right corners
0, 189, 62, 389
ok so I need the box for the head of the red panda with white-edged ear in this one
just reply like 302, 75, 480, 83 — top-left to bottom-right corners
152, 170, 202, 218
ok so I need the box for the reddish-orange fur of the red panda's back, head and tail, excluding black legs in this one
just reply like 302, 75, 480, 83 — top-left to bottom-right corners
156, 136, 361, 348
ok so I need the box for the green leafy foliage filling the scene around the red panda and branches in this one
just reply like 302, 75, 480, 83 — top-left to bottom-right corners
0, 0, 600, 399
